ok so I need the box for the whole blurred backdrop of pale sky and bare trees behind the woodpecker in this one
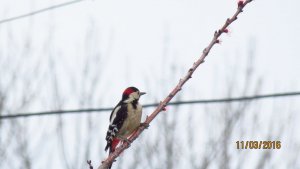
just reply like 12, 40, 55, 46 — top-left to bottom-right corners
0, 0, 300, 169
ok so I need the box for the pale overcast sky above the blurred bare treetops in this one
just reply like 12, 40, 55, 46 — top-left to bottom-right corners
0, 0, 300, 99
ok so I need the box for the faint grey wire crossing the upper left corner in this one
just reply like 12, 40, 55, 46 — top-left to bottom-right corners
0, 0, 84, 24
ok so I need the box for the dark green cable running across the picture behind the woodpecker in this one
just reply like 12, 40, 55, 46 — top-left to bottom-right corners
0, 92, 300, 120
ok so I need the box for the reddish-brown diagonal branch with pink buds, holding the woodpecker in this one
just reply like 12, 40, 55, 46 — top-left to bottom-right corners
98, 0, 252, 169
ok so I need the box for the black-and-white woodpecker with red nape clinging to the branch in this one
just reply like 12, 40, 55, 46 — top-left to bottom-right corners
105, 87, 147, 154
